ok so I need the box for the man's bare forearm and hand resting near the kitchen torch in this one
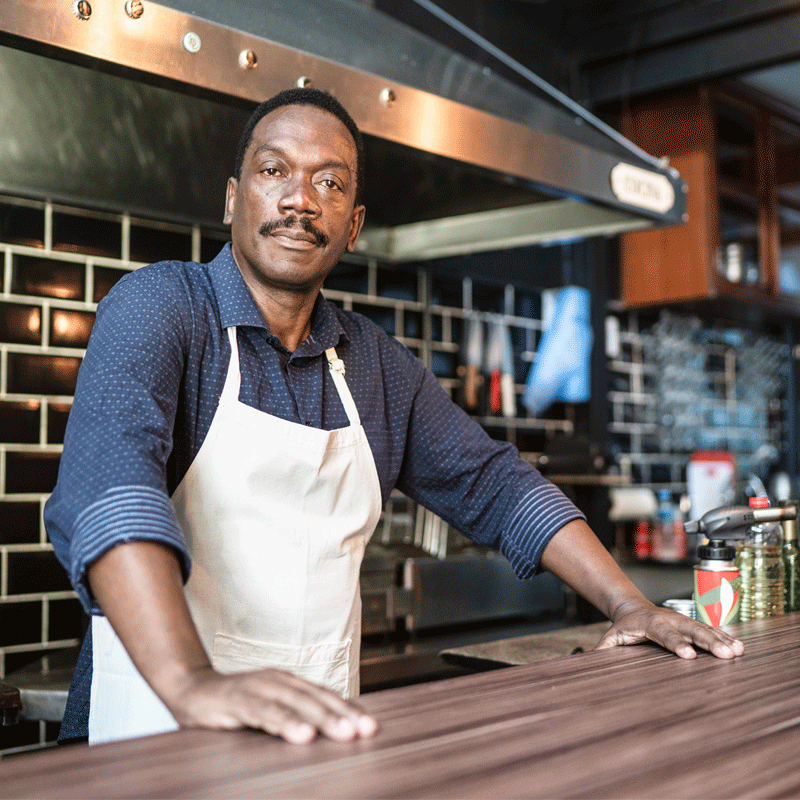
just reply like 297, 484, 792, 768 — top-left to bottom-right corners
541, 520, 744, 658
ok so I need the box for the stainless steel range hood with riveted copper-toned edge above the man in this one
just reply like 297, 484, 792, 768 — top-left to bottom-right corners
0, 0, 685, 261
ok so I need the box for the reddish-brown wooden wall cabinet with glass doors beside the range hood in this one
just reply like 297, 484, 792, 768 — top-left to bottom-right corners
620, 86, 800, 316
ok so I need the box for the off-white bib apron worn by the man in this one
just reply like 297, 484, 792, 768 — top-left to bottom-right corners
89, 327, 381, 743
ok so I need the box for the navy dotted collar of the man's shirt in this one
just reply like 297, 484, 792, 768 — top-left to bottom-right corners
208, 243, 346, 357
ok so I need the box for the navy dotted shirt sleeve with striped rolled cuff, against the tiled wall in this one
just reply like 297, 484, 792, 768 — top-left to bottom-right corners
44, 270, 190, 613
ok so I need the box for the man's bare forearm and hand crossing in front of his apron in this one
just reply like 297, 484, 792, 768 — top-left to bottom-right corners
88, 542, 377, 743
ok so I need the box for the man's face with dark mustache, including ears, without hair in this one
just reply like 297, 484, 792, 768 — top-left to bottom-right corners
224, 105, 364, 293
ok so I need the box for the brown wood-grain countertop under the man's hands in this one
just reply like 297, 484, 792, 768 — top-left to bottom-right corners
0, 612, 800, 798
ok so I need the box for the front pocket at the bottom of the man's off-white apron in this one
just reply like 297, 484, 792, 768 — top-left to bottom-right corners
212, 633, 350, 697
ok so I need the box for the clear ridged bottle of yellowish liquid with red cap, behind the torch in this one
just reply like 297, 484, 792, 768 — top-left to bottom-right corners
736, 497, 783, 622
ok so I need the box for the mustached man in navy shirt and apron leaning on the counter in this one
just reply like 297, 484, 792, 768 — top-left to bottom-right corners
45, 89, 742, 742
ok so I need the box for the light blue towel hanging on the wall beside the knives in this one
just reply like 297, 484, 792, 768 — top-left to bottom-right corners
522, 286, 593, 417
